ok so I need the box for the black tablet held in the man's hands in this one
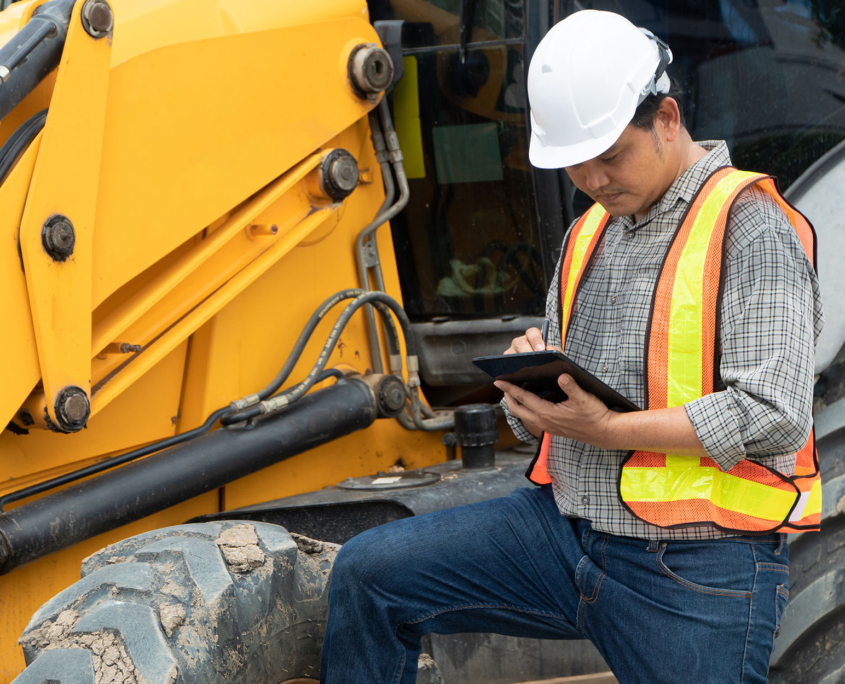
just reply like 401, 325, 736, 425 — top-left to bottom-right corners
472, 350, 640, 411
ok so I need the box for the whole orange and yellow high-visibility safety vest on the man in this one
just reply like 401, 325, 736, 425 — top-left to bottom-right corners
526, 167, 822, 534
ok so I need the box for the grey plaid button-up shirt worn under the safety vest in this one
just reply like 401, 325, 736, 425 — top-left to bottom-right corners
502, 141, 824, 539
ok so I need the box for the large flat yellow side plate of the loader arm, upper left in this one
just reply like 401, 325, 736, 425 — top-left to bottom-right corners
93, 15, 377, 306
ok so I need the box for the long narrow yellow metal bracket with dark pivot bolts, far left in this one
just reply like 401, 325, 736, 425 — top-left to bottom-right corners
20, 0, 112, 432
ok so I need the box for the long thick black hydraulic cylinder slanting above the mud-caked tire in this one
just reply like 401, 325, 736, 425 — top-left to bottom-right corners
0, 378, 379, 574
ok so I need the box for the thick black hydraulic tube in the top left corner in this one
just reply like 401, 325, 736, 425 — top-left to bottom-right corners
0, 0, 76, 119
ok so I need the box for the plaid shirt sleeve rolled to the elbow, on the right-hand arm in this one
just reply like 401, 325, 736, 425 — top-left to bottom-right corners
685, 188, 824, 471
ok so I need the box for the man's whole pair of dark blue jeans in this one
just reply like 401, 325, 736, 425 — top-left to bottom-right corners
321, 486, 789, 684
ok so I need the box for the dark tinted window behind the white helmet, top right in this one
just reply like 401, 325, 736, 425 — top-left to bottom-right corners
561, 0, 845, 194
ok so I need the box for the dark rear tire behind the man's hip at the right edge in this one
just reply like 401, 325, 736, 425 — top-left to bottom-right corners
769, 430, 845, 684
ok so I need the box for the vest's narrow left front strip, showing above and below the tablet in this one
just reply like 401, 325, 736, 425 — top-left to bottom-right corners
526, 204, 610, 485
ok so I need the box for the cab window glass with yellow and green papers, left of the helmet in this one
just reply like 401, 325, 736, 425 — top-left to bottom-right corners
391, 45, 547, 319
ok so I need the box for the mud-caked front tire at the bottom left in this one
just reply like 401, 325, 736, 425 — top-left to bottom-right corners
13, 521, 339, 684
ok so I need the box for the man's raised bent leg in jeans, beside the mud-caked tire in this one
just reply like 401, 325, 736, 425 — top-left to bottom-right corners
321, 488, 583, 684
